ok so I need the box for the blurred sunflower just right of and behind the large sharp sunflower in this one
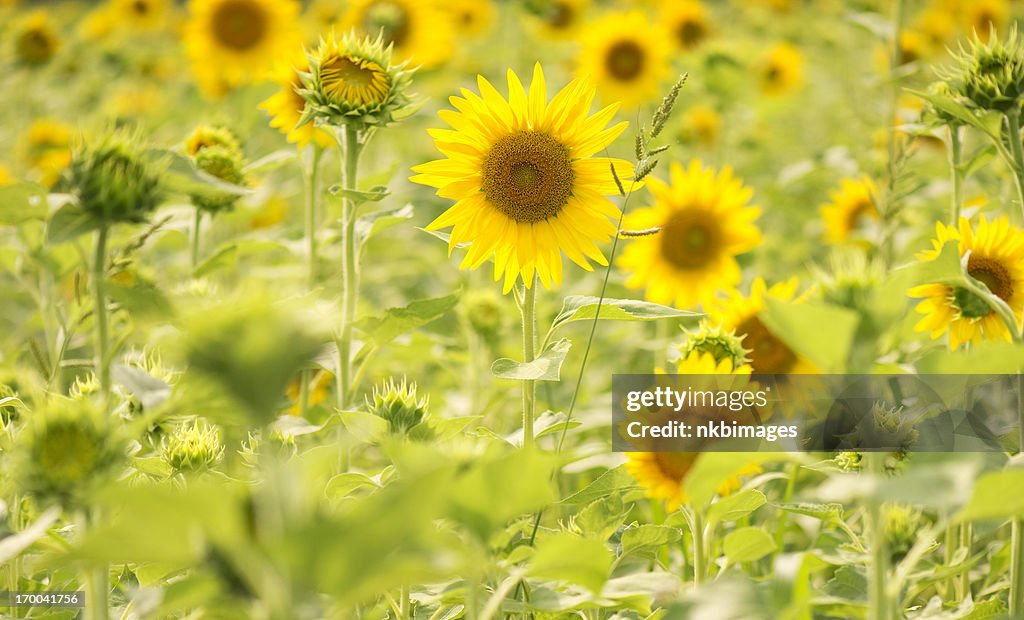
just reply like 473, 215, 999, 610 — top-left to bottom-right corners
618, 160, 761, 307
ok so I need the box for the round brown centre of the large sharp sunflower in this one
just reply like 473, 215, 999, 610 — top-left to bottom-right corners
480, 131, 573, 223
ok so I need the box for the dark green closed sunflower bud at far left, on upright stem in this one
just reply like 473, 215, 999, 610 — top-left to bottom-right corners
68, 133, 161, 225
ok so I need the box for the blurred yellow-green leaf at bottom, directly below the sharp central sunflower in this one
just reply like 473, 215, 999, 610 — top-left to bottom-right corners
526, 534, 612, 594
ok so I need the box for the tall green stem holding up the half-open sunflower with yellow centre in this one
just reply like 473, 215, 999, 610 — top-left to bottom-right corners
337, 125, 361, 409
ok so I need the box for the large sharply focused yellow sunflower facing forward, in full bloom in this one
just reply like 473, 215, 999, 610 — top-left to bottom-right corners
412, 64, 633, 293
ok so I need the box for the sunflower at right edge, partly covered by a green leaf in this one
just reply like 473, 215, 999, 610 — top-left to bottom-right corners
908, 216, 1024, 349
